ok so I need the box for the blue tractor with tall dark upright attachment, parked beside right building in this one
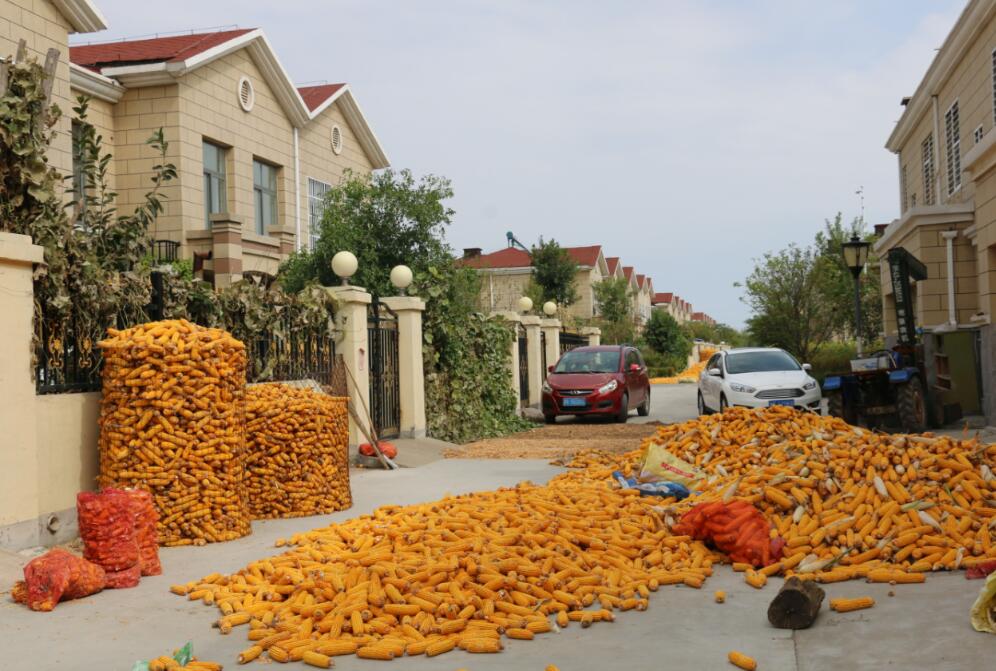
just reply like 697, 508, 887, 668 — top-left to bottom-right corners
823, 247, 930, 433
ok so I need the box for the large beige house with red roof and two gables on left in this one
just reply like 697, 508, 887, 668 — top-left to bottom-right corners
65, 25, 389, 286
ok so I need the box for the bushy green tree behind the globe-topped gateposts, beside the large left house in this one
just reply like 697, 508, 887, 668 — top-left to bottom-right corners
281, 170, 453, 296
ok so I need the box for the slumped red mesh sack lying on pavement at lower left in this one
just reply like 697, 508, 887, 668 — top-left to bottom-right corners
22, 549, 104, 611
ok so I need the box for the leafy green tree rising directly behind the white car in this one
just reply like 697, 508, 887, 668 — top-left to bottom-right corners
735, 245, 841, 360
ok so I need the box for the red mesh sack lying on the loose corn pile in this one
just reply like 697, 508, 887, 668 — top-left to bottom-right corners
674, 499, 784, 567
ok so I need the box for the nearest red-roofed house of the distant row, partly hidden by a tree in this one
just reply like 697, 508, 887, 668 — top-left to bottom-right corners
460, 245, 609, 319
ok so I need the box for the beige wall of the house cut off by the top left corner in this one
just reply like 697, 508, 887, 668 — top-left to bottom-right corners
0, 0, 73, 175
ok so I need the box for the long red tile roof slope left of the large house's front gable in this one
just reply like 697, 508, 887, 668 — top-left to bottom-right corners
69, 28, 255, 70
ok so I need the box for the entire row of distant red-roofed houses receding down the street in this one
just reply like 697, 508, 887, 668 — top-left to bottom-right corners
460, 245, 715, 324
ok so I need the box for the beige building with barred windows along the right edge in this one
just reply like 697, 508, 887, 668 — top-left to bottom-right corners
874, 0, 996, 421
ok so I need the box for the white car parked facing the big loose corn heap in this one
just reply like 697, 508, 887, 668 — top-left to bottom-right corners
699, 347, 822, 415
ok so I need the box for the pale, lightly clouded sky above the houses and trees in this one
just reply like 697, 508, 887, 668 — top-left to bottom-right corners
74, 0, 964, 326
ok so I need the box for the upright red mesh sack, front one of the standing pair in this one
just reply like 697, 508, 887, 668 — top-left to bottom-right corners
76, 489, 139, 571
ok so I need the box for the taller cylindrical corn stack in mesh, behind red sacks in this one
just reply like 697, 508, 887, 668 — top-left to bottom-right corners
98, 319, 250, 545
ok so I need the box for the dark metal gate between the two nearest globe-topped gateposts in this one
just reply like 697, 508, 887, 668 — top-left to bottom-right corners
367, 299, 401, 438
